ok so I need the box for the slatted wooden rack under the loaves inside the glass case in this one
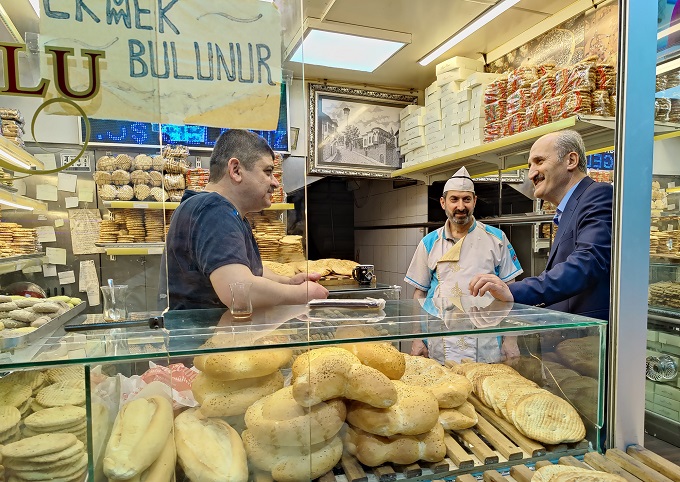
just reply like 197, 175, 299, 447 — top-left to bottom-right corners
318, 399, 589, 482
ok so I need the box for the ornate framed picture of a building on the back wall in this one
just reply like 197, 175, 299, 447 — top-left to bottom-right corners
307, 83, 418, 178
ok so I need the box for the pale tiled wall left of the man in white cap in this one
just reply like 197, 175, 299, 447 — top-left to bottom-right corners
354, 180, 427, 299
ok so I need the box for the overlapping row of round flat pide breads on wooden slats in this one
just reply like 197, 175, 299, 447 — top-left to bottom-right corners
456, 363, 586, 444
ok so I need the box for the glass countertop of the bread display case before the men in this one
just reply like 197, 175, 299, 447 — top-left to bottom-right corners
0, 299, 607, 368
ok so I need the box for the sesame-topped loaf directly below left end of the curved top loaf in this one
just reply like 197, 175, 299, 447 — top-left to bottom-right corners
245, 387, 347, 447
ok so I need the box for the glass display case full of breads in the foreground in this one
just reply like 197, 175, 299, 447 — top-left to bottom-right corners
0, 297, 606, 481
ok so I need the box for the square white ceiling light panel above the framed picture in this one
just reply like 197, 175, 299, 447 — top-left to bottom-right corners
290, 18, 411, 72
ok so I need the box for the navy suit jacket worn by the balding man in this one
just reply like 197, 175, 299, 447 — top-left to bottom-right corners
509, 177, 613, 320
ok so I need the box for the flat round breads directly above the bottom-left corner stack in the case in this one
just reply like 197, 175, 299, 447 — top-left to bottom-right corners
23, 405, 87, 443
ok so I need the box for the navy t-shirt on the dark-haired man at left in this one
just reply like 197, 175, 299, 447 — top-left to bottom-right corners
161, 190, 262, 310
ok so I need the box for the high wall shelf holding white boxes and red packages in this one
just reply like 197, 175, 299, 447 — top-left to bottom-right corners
392, 115, 680, 184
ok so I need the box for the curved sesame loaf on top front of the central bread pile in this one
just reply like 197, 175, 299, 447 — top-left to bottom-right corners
293, 347, 397, 408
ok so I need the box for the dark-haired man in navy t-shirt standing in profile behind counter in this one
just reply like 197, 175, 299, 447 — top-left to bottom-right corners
161, 129, 328, 310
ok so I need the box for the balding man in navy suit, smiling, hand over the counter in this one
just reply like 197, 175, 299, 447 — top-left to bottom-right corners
469, 130, 613, 320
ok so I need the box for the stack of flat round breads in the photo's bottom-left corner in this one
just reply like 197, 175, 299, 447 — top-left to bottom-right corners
0, 433, 87, 482
